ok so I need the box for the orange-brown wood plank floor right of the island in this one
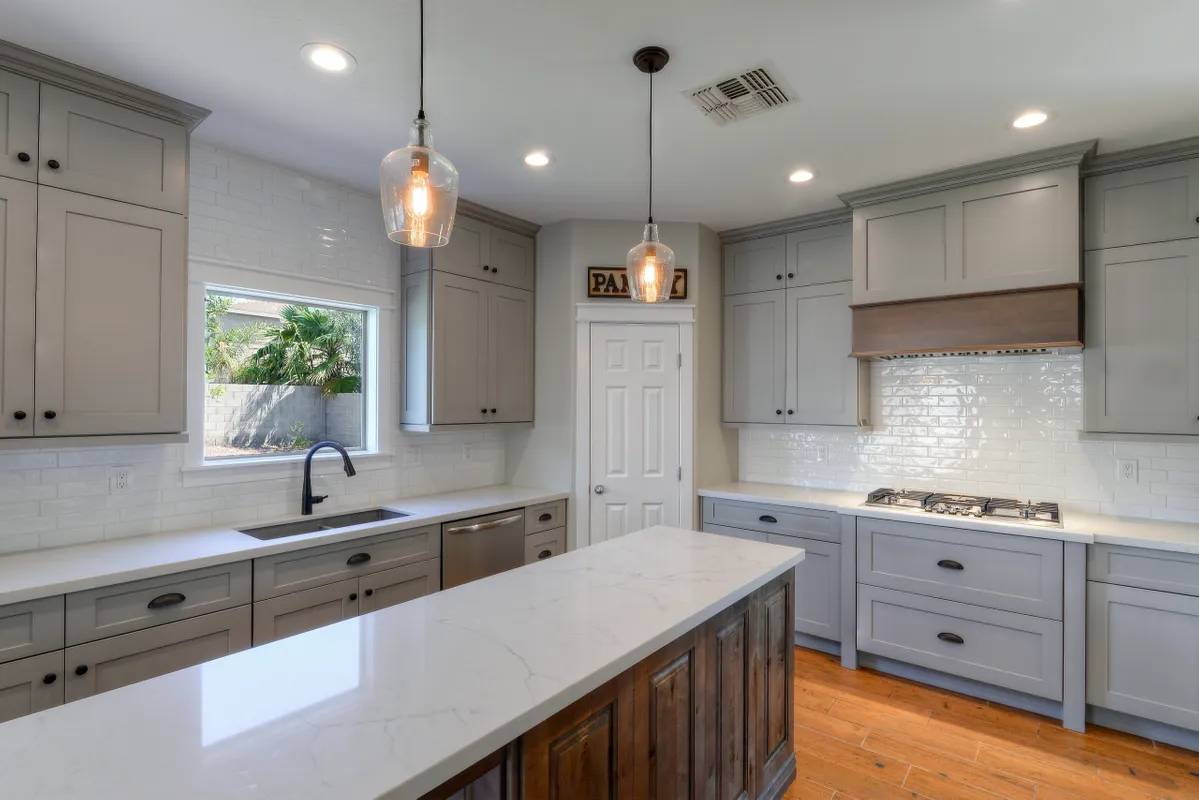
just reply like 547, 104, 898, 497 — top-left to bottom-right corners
785, 648, 1199, 800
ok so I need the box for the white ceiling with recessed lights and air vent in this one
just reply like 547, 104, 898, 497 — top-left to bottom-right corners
0, 0, 1199, 229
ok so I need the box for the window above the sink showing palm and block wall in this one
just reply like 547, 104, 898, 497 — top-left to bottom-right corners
203, 285, 378, 464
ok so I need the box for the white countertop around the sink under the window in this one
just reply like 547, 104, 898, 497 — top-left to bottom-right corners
0, 486, 567, 604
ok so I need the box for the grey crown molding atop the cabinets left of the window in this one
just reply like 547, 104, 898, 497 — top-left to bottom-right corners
0, 40, 212, 131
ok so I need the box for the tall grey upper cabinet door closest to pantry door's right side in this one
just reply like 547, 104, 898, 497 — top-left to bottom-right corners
724, 289, 787, 422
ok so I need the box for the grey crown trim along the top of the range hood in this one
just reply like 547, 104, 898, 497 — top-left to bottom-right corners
838, 139, 1098, 209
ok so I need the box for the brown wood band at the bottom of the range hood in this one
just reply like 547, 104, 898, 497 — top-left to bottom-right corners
851, 283, 1083, 359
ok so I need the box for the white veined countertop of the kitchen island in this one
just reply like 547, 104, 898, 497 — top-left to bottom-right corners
0, 527, 803, 800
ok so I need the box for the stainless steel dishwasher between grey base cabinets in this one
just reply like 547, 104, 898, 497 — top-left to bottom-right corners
441, 509, 524, 589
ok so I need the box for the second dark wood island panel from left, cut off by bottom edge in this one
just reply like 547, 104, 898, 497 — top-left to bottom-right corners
520, 672, 638, 800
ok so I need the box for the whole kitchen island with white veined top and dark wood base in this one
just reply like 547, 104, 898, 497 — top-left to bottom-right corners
0, 527, 803, 800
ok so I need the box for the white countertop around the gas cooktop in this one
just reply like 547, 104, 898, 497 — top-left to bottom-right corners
699, 482, 1199, 553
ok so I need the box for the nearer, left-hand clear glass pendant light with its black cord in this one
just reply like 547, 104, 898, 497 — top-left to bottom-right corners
379, 0, 458, 247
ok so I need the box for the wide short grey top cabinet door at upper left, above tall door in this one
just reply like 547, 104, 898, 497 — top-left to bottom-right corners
37, 84, 187, 213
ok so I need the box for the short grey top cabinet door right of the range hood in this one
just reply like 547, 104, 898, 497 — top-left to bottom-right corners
1084, 158, 1199, 249
